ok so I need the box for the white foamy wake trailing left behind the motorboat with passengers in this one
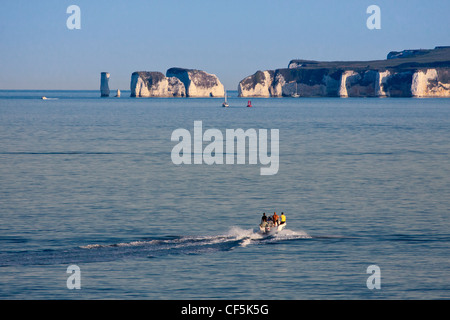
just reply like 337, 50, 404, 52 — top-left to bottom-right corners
0, 227, 311, 267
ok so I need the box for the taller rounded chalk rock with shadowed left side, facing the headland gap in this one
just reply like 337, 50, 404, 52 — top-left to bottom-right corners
166, 68, 225, 97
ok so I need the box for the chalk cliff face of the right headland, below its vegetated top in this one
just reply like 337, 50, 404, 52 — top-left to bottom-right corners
238, 68, 450, 97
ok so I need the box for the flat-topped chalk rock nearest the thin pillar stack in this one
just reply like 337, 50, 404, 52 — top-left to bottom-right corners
130, 71, 186, 97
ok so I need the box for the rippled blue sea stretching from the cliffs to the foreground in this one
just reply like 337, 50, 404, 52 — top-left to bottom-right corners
0, 91, 450, 300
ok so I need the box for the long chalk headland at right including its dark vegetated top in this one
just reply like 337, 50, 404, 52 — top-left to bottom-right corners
238, 47, 450, 97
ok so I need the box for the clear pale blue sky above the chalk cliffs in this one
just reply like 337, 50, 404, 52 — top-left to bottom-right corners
0, 0, 450, 90
